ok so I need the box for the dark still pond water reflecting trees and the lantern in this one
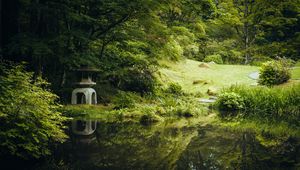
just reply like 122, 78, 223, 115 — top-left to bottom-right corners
48, 119, 300, 170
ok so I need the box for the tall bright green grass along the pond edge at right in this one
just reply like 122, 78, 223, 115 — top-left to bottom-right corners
217, 84, 300, 125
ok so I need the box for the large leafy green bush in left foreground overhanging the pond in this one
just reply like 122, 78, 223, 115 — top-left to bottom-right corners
0, 64, 66, 159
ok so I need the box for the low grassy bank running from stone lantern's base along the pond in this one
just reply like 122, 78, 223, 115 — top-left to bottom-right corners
61, 93, 216, 124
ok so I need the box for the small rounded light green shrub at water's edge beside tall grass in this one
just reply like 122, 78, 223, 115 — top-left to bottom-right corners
217, 92, 245, 111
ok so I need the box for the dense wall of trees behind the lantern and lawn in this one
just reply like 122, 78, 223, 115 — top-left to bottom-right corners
0, 0, 300, 100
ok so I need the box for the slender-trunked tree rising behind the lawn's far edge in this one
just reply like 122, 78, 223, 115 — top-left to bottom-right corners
212, 0, 259, 64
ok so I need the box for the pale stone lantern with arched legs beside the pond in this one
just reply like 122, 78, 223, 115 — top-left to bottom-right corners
71, 67, 98, 104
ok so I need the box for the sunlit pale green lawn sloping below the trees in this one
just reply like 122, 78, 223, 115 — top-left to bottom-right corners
158, 59, 258, 94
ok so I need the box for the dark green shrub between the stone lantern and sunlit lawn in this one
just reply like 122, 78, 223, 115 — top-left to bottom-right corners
100, 51, 156, 94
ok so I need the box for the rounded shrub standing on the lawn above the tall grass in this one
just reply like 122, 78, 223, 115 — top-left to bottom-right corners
258, 60, 291, 86
